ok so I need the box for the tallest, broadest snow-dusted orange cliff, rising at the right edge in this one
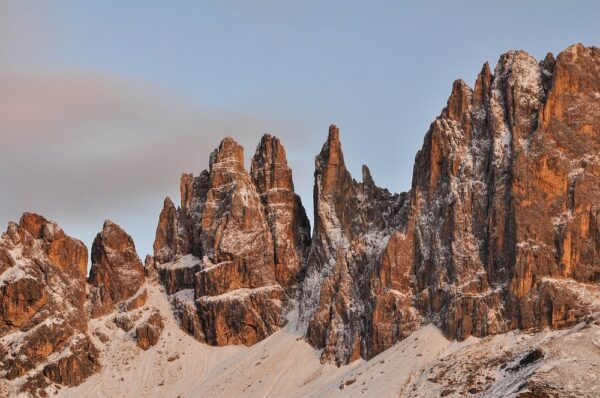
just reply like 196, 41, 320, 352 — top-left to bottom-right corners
413, 45, 600, 338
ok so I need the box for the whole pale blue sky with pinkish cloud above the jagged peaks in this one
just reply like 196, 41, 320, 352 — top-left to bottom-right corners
0, 0, 600, 256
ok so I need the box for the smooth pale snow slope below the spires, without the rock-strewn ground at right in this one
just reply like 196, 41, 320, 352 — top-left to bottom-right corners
49, 284, 449, 398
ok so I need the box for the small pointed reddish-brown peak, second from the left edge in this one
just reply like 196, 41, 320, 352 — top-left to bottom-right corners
89, 220, 145, 318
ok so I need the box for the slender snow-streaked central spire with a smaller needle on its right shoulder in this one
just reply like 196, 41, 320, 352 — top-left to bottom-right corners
301, 125, 408, 364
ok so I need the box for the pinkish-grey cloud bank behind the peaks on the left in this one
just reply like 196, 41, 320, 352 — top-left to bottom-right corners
0, 72, 312, 258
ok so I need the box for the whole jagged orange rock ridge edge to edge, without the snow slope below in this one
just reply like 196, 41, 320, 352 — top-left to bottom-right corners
0, 45, 600, 396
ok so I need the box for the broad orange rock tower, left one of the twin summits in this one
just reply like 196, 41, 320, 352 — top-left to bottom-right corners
201, 138, 276, 282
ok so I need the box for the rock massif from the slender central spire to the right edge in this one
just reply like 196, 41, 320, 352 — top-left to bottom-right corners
301, 45, 600, 364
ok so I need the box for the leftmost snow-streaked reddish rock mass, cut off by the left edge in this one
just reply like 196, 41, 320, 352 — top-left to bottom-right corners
0, 213, 100, 393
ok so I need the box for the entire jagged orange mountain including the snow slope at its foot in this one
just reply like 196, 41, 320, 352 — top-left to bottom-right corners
0, 44, 600, 398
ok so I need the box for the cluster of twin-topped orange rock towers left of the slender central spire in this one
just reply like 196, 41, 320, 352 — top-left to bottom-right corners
154, 136, 310, 345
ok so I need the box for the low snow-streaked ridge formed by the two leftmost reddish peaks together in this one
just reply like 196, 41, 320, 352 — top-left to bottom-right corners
0, 213, 145, 396
